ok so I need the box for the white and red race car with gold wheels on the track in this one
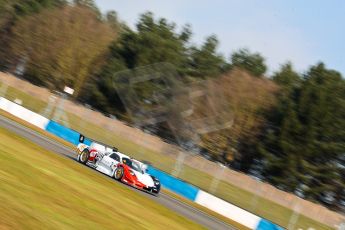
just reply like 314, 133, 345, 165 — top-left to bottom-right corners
77, 142, 160, 194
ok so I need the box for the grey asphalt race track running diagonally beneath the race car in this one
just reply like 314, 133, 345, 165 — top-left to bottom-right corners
0, 116, 235, 230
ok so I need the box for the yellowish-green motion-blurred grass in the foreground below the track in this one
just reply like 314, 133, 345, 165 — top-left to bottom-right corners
0, 128, 201, 229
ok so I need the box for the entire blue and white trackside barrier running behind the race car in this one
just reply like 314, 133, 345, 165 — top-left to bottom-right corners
0, 97, 282, 230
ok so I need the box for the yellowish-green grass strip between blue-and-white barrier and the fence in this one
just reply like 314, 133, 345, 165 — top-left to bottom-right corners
0, 81, 332, 230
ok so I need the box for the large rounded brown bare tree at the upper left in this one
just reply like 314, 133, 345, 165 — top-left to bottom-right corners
11, 6, 116, 96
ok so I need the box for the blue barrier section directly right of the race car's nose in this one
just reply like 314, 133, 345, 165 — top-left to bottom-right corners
147, 166, 199, 201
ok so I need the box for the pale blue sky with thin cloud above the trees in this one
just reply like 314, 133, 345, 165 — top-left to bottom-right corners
95, 0, 345, 76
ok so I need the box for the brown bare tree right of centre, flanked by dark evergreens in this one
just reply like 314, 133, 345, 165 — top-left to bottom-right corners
201, 69, 278, 162
